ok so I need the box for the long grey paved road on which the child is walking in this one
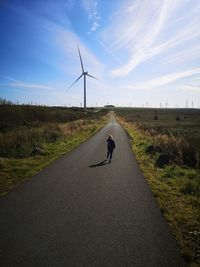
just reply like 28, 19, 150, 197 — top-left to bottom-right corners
0, 116, 185, 267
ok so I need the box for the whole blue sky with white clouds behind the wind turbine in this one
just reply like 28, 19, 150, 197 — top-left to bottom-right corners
0, 0, 200, 108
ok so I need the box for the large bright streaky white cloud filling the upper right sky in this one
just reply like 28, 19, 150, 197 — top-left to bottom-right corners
102, 0, 200, 77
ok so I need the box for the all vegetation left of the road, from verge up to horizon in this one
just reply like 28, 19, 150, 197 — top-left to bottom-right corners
0, 103, 107, 196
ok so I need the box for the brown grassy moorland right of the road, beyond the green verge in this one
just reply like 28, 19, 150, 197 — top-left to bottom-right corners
116, 108, 200, 169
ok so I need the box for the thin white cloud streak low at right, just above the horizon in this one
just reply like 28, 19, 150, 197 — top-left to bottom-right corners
127, 68, 200, 90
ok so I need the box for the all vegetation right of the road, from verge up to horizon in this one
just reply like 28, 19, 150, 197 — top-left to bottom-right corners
115, 108, 200, 267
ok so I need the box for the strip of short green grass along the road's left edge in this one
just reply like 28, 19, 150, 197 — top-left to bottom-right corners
0, 118, 105, 196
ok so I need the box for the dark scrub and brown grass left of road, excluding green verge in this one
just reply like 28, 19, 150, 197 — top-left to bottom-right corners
0, 103, 107, 158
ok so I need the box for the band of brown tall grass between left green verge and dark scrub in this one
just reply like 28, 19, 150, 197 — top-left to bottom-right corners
0, 120, 104, 158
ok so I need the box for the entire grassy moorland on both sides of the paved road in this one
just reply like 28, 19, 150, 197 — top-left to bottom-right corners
0, 104, 200, 267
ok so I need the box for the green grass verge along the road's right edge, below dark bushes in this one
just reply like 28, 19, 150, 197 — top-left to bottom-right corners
120, 120, 200, 267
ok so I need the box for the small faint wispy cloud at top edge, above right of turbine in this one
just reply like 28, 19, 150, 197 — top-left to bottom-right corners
82, 0, 101, 34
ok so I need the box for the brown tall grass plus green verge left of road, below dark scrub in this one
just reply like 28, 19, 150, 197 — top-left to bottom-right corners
0, 111, 107, 196
